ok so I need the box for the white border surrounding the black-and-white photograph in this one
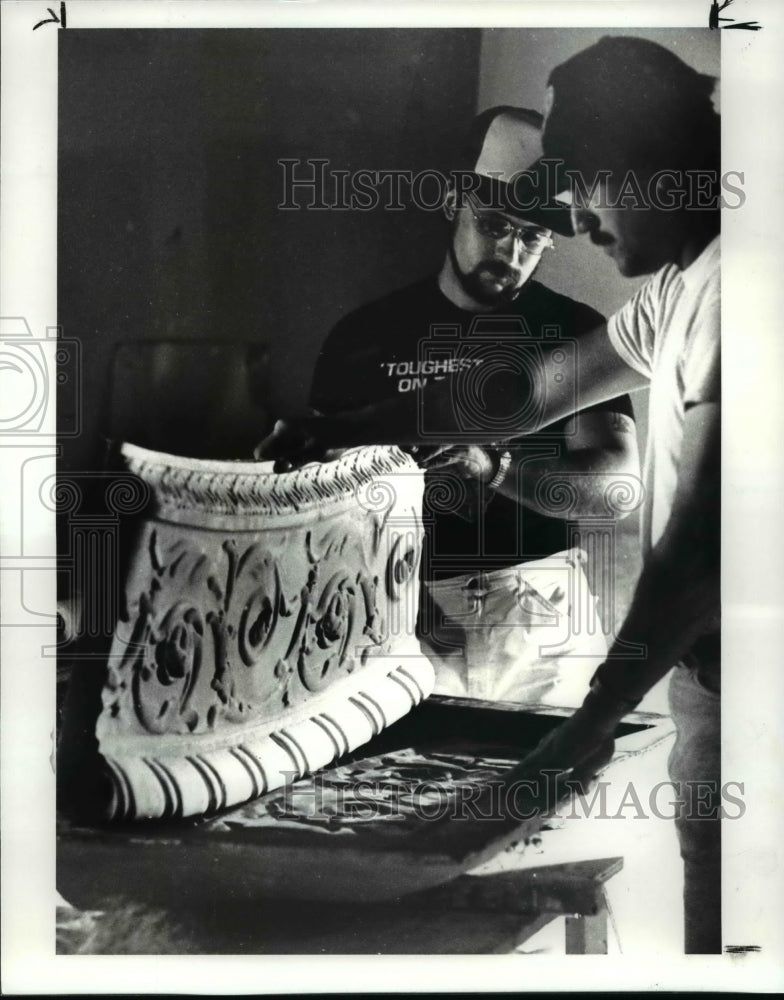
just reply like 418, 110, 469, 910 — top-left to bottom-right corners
0, 0, 784, 994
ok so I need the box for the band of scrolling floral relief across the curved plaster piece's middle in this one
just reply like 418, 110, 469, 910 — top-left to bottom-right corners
106, 460, 419, 735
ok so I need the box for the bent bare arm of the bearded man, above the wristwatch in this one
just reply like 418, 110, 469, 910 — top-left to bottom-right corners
498, 410, 642, 518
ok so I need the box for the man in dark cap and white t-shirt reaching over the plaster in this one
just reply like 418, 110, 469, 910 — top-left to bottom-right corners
261, 37, 721, 953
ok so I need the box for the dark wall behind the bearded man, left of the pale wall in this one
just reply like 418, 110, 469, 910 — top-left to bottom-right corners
58, 29, 480, 469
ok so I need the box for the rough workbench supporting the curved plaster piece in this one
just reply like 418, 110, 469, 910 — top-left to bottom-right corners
58, 699, 672, 954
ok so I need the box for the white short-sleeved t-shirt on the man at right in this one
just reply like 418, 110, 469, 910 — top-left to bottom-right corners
607, 236, 721, 552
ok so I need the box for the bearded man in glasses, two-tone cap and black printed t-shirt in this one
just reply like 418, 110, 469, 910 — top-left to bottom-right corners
311, 107, 638, 705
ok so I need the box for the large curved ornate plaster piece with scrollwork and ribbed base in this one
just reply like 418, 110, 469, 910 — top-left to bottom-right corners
57, 445, 434, 820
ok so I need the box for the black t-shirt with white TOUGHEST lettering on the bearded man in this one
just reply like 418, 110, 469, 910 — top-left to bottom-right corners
310, 276, 632, 579
